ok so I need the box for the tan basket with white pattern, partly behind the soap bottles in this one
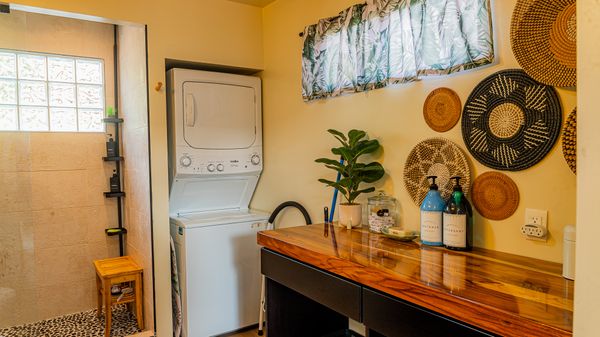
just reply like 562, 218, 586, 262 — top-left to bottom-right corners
404, 138, 471, 206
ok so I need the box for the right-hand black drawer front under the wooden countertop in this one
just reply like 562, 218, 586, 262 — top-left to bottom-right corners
363, 288, 494, 337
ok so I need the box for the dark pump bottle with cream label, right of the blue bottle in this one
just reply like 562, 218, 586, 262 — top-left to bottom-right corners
443, 177, 473, 250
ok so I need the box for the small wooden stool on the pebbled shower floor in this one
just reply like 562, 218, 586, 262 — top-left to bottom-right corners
94, 256, 144, 337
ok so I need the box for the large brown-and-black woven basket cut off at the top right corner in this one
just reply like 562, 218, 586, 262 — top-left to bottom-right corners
510, 0, 577, 87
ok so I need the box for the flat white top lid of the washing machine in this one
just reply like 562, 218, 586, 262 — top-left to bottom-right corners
171, 210, 269, 229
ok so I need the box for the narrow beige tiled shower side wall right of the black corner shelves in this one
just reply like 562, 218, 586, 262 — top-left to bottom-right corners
118, 26, 154, 330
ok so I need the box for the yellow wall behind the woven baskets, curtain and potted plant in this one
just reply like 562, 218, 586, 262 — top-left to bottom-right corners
253, 0, 576, 261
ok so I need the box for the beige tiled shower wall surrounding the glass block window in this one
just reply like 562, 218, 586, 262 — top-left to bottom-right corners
0, 11, 118, 328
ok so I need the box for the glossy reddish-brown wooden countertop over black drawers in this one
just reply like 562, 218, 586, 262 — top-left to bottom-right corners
258, 224, 573, 337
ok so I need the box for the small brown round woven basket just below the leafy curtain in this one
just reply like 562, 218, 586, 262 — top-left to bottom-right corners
423, 88, 462, 132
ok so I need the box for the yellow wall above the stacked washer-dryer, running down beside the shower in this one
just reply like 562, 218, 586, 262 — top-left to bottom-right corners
10, 0, 263, 337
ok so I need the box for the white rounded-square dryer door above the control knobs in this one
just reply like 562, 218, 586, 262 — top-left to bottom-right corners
181, 82, 259, 150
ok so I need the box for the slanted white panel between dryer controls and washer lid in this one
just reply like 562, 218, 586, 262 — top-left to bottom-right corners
169, 175, 258, 216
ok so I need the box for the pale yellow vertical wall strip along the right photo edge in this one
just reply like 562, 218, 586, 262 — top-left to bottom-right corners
574, 1, 600, 337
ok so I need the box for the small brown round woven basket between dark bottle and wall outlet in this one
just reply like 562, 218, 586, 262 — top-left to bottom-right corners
471, 172, 519, 220
